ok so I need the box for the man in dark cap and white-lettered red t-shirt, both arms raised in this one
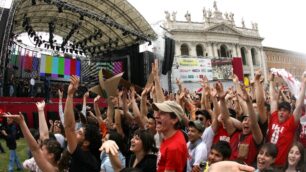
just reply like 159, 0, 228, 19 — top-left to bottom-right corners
267, 75, 306, 166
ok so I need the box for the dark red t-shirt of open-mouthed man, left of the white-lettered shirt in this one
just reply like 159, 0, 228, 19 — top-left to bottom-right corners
230, 132, 258, 165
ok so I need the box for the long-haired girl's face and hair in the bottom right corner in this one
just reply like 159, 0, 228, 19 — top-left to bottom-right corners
284, 142, 306, 172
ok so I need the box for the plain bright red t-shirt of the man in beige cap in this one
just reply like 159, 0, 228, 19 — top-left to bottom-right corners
157, 131, 188, 172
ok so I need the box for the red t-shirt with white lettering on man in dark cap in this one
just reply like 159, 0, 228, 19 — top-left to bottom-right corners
267, 111, 297, 166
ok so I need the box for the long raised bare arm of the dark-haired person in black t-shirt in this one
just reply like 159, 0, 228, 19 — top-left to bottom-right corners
64, 75, 79, 154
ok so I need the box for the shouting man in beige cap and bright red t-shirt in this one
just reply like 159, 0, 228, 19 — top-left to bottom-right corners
153, 101, 188, 172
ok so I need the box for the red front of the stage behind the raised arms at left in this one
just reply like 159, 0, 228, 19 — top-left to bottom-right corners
0, 97, 107, 128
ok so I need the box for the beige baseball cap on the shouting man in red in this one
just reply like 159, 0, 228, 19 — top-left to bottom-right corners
153, 101, 184, 121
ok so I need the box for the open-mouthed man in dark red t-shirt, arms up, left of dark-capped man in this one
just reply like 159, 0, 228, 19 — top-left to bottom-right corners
216, 82, 263, 165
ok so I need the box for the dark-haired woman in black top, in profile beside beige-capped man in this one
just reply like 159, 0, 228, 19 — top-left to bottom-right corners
129, 130, 157, 172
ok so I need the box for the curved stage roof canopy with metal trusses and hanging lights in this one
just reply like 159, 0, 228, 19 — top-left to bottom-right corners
13, 0, 156, 54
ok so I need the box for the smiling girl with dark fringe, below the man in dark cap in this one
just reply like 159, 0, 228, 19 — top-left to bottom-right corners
255, 143, 278, 172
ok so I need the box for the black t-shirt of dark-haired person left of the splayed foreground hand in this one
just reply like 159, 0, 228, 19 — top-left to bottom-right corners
69, 146, 100, 172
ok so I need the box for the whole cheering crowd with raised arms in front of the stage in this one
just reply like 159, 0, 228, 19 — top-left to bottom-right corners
1, 58, 306, 172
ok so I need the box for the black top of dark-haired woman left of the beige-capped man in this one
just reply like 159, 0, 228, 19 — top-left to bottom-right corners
129, 154, 157, 172
